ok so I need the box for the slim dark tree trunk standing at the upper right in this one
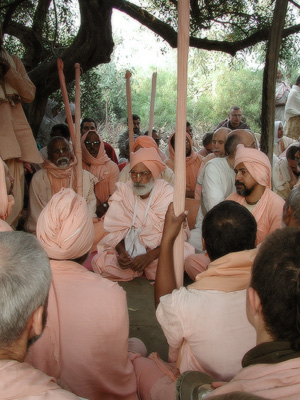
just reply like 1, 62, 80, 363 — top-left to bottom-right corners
261, 0, 288, 164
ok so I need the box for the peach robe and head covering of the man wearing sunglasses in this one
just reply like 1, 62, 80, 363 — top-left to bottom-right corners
81, 132, 119, 204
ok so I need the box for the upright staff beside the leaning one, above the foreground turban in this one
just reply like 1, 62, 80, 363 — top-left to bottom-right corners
75, 63, 83, 196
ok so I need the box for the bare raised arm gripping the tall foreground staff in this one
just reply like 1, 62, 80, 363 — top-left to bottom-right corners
154, 203, 187, 307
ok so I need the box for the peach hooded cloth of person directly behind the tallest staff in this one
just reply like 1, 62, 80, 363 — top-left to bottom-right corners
166, 133, 202, 191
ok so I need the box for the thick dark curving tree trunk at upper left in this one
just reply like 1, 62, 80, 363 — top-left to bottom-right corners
26, 0, 114, 137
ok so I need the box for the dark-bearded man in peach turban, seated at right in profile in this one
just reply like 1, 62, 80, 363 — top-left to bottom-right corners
227, 144, 284, 245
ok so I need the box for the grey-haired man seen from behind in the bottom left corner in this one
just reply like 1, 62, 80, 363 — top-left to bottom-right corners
0, 232, 79, 400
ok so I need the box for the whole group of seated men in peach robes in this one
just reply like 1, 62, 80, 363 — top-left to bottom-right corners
0, 107, 300, 400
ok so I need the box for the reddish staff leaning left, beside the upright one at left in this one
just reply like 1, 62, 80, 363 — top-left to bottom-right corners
57, 58, 82, 196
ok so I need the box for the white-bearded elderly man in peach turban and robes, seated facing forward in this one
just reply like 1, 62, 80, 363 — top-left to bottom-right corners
92, 148, 194, 281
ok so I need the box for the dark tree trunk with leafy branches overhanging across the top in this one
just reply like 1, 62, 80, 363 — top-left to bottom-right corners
0, 0, 300, 133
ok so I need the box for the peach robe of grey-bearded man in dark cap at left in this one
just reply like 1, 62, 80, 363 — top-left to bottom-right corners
25, 160, 97, 232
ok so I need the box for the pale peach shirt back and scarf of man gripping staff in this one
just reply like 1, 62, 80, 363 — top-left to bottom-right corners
157, 252, 255, 380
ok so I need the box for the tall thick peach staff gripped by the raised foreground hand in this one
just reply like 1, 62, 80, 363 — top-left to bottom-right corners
174, 0, 190, 288
